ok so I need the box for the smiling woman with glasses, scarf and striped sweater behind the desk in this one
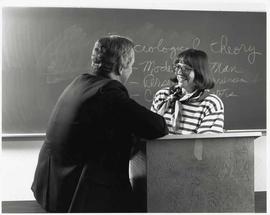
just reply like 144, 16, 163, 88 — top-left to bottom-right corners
151, 49, 224, 134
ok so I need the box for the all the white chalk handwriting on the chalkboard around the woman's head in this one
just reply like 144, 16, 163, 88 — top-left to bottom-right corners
132, 35, 262, 102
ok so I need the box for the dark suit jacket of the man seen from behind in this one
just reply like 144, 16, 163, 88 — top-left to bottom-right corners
32, 74, 168, 212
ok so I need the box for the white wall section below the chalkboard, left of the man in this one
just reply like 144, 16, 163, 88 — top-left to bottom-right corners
1, 141, 42, 200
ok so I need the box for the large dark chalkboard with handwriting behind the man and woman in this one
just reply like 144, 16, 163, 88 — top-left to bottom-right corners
2, 7, 266, 133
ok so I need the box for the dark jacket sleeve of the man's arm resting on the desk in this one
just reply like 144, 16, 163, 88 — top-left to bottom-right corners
104, 81, 168, 139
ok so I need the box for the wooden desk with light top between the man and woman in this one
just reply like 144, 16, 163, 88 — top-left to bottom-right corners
142, 132, 261, 212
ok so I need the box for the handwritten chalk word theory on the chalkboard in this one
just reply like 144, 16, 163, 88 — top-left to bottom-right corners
210, 35, 262, 64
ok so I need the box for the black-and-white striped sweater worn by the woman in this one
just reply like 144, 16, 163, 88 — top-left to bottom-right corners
151, 87, 224, 134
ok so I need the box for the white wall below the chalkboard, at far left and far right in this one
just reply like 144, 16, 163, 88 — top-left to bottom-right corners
1, 136, 267, 201
